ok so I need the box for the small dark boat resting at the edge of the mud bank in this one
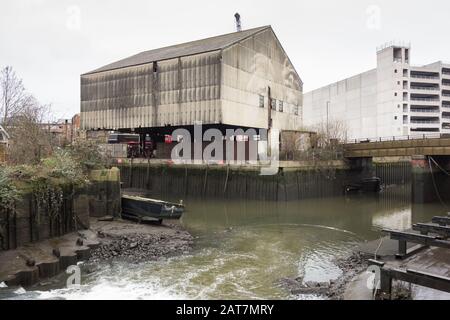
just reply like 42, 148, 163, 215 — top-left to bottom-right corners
122, 195, 184, 223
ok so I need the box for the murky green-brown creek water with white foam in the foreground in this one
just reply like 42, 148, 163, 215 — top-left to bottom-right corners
3, 186, 446, 299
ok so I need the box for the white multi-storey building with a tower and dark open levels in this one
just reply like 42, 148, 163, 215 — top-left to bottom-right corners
303, 44, 450, 140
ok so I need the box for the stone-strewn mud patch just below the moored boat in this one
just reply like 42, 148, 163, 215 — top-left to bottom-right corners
89, 220, 193, 263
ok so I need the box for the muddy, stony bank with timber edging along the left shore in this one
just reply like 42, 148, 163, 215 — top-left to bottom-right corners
0, 218, 193, 290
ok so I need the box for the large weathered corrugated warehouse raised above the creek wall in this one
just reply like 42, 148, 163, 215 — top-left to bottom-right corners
81, 26, 303, 148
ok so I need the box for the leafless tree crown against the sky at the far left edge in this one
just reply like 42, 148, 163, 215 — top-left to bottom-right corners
0, 66, 34, 127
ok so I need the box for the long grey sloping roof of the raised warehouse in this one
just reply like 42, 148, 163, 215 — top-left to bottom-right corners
86, 26, 271, 74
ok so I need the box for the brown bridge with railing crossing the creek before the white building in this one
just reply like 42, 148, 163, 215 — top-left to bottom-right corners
344, 134, 450, 158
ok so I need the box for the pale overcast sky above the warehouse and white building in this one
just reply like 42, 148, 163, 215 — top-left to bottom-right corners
0, 0, 450, 118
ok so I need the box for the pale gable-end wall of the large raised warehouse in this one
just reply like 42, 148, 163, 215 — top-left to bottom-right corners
222, 28, 302, 130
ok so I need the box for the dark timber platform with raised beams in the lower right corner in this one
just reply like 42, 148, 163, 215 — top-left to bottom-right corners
359, 216, 450, 295
